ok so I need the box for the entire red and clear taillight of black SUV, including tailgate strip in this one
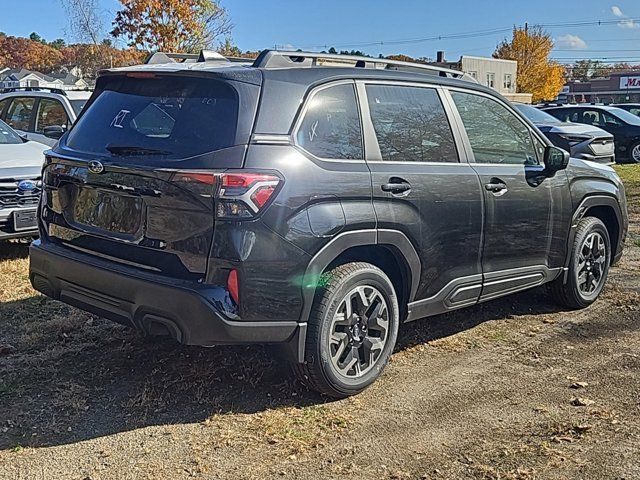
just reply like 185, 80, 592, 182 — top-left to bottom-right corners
174, 171, 280, 220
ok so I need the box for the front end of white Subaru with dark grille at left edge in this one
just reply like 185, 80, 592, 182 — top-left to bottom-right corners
0, 120, 48, 241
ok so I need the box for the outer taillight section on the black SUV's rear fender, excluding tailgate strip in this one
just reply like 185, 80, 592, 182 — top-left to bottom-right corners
216, 172, 280, 220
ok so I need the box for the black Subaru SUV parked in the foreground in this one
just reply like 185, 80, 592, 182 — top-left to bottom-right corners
30, 51, 627, 397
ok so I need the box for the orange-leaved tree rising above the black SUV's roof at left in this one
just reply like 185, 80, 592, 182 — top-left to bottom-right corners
111, 0, 232, 52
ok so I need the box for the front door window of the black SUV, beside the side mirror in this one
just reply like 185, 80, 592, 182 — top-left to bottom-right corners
451, 92, 539, 165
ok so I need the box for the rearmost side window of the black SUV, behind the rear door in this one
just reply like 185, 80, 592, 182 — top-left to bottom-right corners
296, 84, 363, 160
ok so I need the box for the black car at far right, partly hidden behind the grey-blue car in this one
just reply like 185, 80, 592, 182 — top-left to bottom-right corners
543, 105, 640, 163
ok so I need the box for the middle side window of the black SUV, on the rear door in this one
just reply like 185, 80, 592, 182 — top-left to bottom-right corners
366, 85, 458, 162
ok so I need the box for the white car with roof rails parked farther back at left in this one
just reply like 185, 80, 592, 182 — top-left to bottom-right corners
0, 87, 91, 147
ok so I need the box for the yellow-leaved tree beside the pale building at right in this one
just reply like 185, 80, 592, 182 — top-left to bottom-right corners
493, 26, 564, 102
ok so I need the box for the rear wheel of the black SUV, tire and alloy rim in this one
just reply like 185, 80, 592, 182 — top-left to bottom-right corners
296, 262, 400, 398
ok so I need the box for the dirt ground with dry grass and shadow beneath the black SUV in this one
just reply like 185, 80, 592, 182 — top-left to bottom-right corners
0, 166, 640, 480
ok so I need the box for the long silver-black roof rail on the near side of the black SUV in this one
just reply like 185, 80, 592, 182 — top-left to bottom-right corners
253, 50, 478, 83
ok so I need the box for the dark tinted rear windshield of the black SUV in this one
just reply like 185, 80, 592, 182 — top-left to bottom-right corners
67, 76, 238, 159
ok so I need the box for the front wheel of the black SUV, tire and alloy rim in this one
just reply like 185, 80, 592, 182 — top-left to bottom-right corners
551, 217, 611, 309
